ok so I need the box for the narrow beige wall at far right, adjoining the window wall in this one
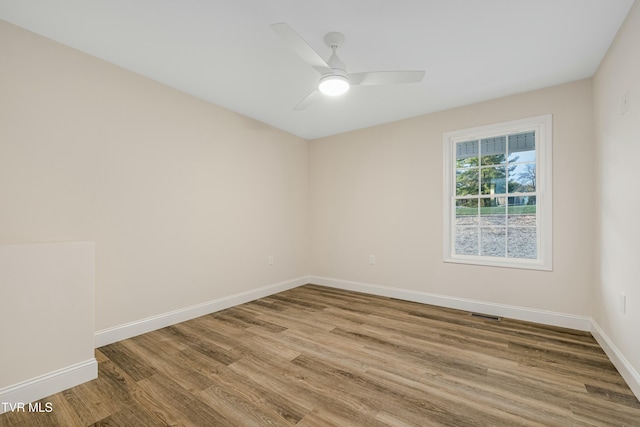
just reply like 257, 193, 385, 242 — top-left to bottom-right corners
593, 1, 640, 396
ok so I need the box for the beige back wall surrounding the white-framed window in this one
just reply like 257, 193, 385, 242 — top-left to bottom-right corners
310, 80, 595, 316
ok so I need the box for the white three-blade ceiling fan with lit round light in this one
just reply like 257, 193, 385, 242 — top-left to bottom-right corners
271, 23, 424, 111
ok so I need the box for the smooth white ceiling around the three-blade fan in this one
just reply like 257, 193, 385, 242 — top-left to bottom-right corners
0, 0, 633, 139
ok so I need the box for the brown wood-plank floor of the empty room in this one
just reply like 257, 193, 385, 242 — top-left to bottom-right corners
0, 285, 640, 427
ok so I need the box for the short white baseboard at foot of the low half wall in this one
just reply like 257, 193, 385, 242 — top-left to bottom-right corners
0, 358, 98, 414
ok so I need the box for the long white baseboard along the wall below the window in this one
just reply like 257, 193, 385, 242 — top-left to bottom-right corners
309, 276, 591, 331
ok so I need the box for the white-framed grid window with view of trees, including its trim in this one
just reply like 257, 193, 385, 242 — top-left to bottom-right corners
443, 115, 552, 270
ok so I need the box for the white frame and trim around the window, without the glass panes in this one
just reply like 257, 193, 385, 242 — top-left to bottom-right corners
443, 114, 553, 270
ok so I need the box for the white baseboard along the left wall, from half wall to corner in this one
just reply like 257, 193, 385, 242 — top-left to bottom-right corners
95, 276, 310, 348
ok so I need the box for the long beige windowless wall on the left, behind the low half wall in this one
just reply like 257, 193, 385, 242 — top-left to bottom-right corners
0, 22, 308, 330
